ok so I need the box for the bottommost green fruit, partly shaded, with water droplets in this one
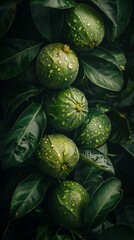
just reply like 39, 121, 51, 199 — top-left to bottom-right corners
48, 181, 89, 229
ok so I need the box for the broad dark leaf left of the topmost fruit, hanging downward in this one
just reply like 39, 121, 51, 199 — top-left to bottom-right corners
31, 5, 64, 42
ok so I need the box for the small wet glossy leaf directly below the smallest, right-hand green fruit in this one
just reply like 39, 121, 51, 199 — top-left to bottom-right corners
79, 147, 114, 174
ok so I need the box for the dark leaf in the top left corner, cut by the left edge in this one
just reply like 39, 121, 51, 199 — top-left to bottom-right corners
0, 1, 16, 38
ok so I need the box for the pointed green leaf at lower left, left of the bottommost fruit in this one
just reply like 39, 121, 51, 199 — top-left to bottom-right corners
10, 173, 48, 219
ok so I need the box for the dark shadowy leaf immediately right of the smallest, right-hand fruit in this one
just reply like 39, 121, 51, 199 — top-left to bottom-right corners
109, 111, 130, 143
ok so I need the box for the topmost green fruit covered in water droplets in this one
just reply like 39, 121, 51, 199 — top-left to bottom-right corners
64, 3, 105, 51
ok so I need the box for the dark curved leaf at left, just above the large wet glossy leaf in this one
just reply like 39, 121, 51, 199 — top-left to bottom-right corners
3, 85, 42, 120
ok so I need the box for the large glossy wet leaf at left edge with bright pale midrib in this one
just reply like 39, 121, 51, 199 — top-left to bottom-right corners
2, 102, 46, 169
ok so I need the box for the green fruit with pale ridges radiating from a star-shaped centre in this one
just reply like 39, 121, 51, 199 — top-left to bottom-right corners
45, 87, 88, 132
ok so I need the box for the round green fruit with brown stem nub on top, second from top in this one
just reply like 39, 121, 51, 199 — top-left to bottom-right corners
36, 43, 79, 89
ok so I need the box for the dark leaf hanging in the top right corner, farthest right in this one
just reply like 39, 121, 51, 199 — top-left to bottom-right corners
113, 0, 132, 38
